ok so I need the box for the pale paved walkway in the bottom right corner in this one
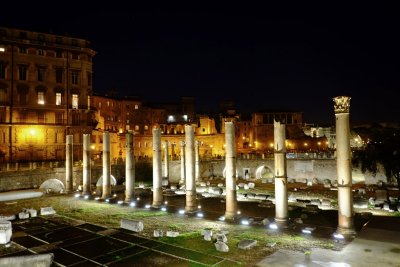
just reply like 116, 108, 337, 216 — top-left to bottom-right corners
257, 217, 400, 267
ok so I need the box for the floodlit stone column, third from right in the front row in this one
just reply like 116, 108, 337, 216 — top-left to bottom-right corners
225, 121, 237, 220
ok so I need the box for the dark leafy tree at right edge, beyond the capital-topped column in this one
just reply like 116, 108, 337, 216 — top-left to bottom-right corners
353, 125, 400, 197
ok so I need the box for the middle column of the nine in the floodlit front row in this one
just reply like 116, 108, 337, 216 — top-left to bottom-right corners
153, 128, 163, 208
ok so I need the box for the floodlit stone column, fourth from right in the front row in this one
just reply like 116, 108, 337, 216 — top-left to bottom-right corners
185, 125, 197, 212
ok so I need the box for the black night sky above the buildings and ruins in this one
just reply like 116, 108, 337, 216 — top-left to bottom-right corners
0, 1, 400, 124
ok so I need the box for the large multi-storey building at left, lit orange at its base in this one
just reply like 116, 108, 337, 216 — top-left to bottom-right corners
0, 27, 96, 162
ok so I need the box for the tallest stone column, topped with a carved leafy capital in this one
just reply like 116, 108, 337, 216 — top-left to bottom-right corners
333, 96, 355, 235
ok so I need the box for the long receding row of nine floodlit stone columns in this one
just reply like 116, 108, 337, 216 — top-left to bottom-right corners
66, 96, 354, 235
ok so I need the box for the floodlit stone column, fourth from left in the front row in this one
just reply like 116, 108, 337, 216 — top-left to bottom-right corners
125, 130, 135, 202
